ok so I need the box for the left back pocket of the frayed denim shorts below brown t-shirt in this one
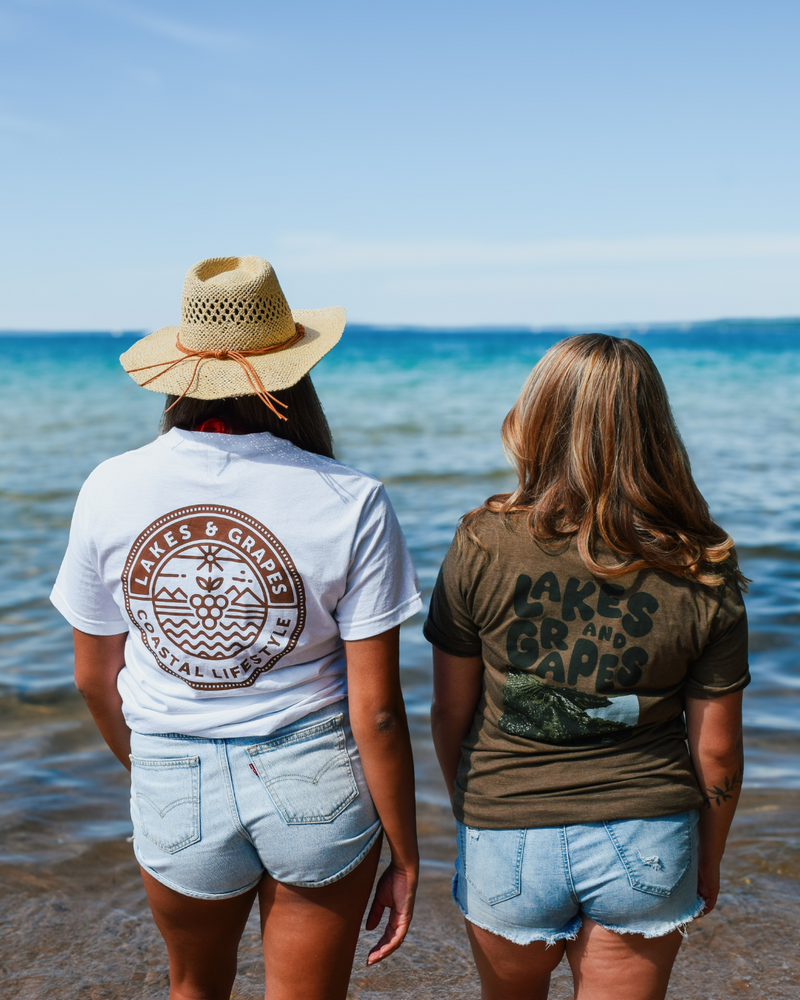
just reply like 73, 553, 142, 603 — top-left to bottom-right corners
456, 823, 525, 906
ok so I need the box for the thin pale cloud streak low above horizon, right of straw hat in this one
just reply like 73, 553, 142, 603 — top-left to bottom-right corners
281, 233, 800, 270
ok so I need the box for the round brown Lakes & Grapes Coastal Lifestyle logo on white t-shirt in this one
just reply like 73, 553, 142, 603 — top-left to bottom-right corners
122, 505, 305, 690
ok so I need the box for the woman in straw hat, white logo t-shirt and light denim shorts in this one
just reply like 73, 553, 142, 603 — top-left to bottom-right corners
52, 257, 421, 1000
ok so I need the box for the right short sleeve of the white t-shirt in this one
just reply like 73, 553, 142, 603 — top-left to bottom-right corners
335, 486, 422, 641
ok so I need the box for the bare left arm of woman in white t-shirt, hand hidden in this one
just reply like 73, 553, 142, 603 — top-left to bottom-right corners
72, 628, 131, 771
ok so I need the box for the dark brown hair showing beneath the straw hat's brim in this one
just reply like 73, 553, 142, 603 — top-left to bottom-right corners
161, 375, 333, 458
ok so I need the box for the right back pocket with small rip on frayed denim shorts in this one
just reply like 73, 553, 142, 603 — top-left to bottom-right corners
605, 810, 697, 896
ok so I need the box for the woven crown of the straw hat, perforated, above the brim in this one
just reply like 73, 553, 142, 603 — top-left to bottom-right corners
180, 257, 295, 351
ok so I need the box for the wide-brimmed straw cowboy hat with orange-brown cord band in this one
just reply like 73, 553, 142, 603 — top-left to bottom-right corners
119, 257, 347, 416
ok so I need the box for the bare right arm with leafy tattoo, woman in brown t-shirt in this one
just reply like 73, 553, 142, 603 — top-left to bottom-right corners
685, 691, 744, 913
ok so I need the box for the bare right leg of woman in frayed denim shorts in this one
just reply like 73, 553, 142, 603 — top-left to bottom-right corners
567, 917, 681, 1000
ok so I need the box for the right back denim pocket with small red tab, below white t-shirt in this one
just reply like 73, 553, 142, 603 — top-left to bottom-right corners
247, 715, 358, 824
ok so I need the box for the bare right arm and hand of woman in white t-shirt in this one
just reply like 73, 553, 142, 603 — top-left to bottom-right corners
344, 627, 419, 965
